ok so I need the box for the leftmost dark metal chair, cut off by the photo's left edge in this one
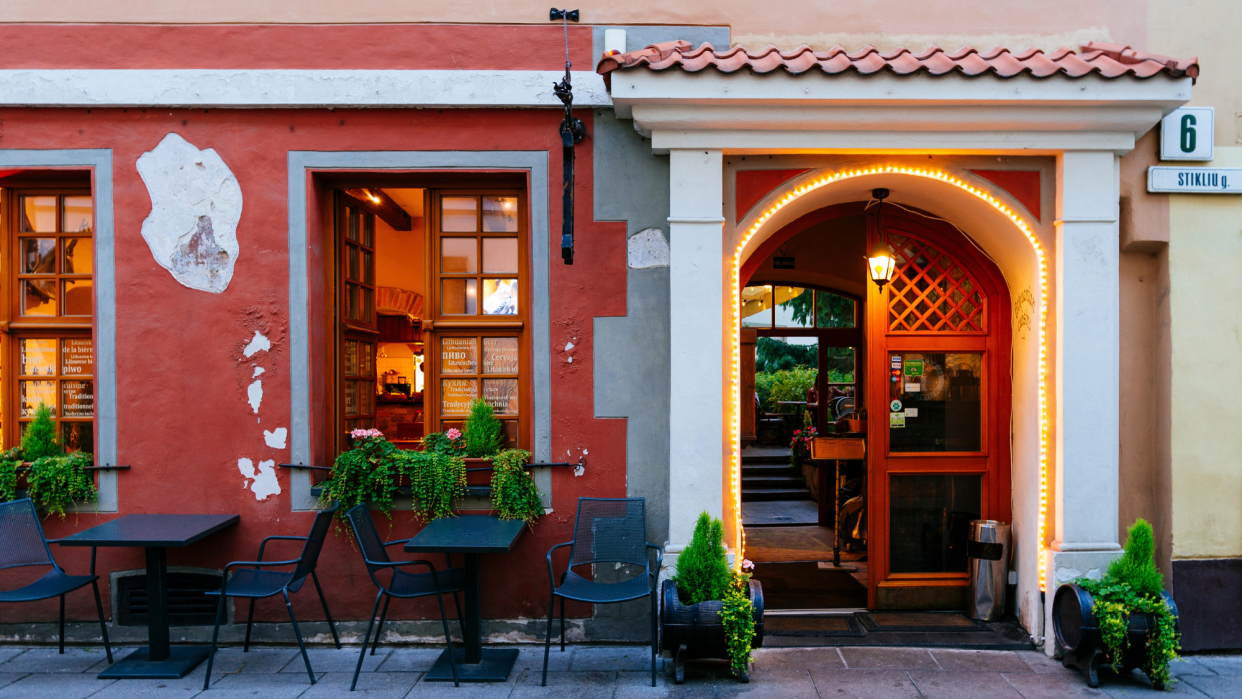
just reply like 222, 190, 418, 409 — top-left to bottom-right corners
0, 498, 112, 663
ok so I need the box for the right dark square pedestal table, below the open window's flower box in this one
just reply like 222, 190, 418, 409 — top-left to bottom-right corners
405, 515, 525, 682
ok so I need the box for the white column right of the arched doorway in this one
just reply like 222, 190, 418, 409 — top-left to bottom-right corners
1045, 150, 1120, 654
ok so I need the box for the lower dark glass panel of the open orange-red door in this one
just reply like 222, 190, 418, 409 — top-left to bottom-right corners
888, 474, 982, 572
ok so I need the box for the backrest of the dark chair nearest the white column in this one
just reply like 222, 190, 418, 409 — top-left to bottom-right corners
569, 498, 650, 567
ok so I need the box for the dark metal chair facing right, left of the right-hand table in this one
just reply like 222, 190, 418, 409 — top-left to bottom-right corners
345, 504, 466, 692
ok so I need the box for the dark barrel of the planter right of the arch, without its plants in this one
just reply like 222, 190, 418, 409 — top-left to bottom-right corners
1052, 582, 1177, 689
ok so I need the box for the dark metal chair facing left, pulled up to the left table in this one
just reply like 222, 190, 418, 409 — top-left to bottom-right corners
202, 504, 340, 689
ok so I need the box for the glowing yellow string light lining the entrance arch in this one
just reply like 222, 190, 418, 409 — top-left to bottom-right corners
729, 165, 1048, 590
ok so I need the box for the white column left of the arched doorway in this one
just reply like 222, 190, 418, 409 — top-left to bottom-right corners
666, 149, 728, 561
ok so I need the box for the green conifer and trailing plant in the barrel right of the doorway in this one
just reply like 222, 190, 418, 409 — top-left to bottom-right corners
1074, 519, 1181, 688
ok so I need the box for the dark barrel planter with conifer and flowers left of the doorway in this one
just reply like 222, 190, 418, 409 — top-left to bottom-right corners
660, 513, 764, 684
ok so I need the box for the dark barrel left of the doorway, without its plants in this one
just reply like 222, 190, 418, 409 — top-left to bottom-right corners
660, 580, 764, 684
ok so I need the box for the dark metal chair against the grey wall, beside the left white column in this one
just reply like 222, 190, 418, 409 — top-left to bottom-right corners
543, 498, 664, 687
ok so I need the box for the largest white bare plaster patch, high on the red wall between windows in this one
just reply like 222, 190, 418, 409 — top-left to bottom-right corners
138, 133, 242, 294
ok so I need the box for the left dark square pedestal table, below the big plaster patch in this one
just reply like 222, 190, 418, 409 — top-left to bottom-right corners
60, 514, 241, 679
